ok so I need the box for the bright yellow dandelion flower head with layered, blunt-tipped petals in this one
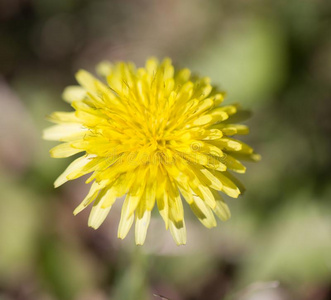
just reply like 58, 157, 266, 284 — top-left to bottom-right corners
44, 58, 259, 245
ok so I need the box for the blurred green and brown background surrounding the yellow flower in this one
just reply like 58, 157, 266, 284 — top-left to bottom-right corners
0, 0, 331, 300
